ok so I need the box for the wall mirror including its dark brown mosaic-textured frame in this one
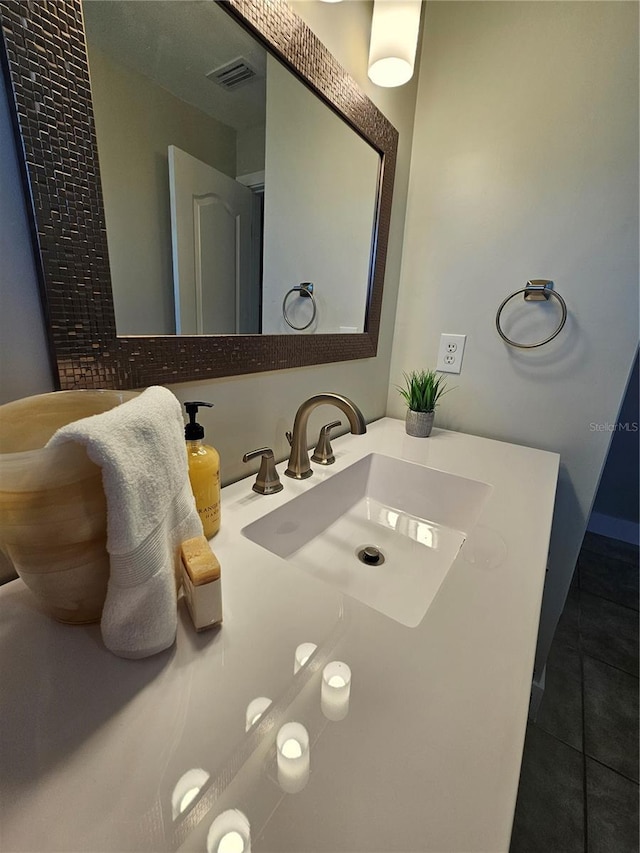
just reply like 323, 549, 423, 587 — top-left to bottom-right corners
0, 0, 397, 388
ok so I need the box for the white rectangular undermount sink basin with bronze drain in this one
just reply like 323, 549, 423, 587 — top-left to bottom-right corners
242, 453, 492, 628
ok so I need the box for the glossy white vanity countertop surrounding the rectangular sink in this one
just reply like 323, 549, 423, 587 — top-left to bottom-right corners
0, 418, 559, 853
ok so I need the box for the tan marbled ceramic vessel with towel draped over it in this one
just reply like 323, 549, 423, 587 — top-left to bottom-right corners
0, 391, 137, 623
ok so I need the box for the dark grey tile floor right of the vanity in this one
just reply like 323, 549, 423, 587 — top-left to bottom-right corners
510, 533, 640, 853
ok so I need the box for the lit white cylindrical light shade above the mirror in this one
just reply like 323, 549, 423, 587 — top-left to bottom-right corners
369, 0, 422, 87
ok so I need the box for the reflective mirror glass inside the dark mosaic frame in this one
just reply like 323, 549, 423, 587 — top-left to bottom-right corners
83, 0, 380, 335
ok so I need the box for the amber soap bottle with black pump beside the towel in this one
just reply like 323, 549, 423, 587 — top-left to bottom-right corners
184, 402, 220, 539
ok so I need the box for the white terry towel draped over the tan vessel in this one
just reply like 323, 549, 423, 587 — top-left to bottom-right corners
47, 386, 202, 658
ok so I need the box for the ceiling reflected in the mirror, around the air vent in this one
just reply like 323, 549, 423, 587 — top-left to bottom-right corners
83, 0, 266, 130
